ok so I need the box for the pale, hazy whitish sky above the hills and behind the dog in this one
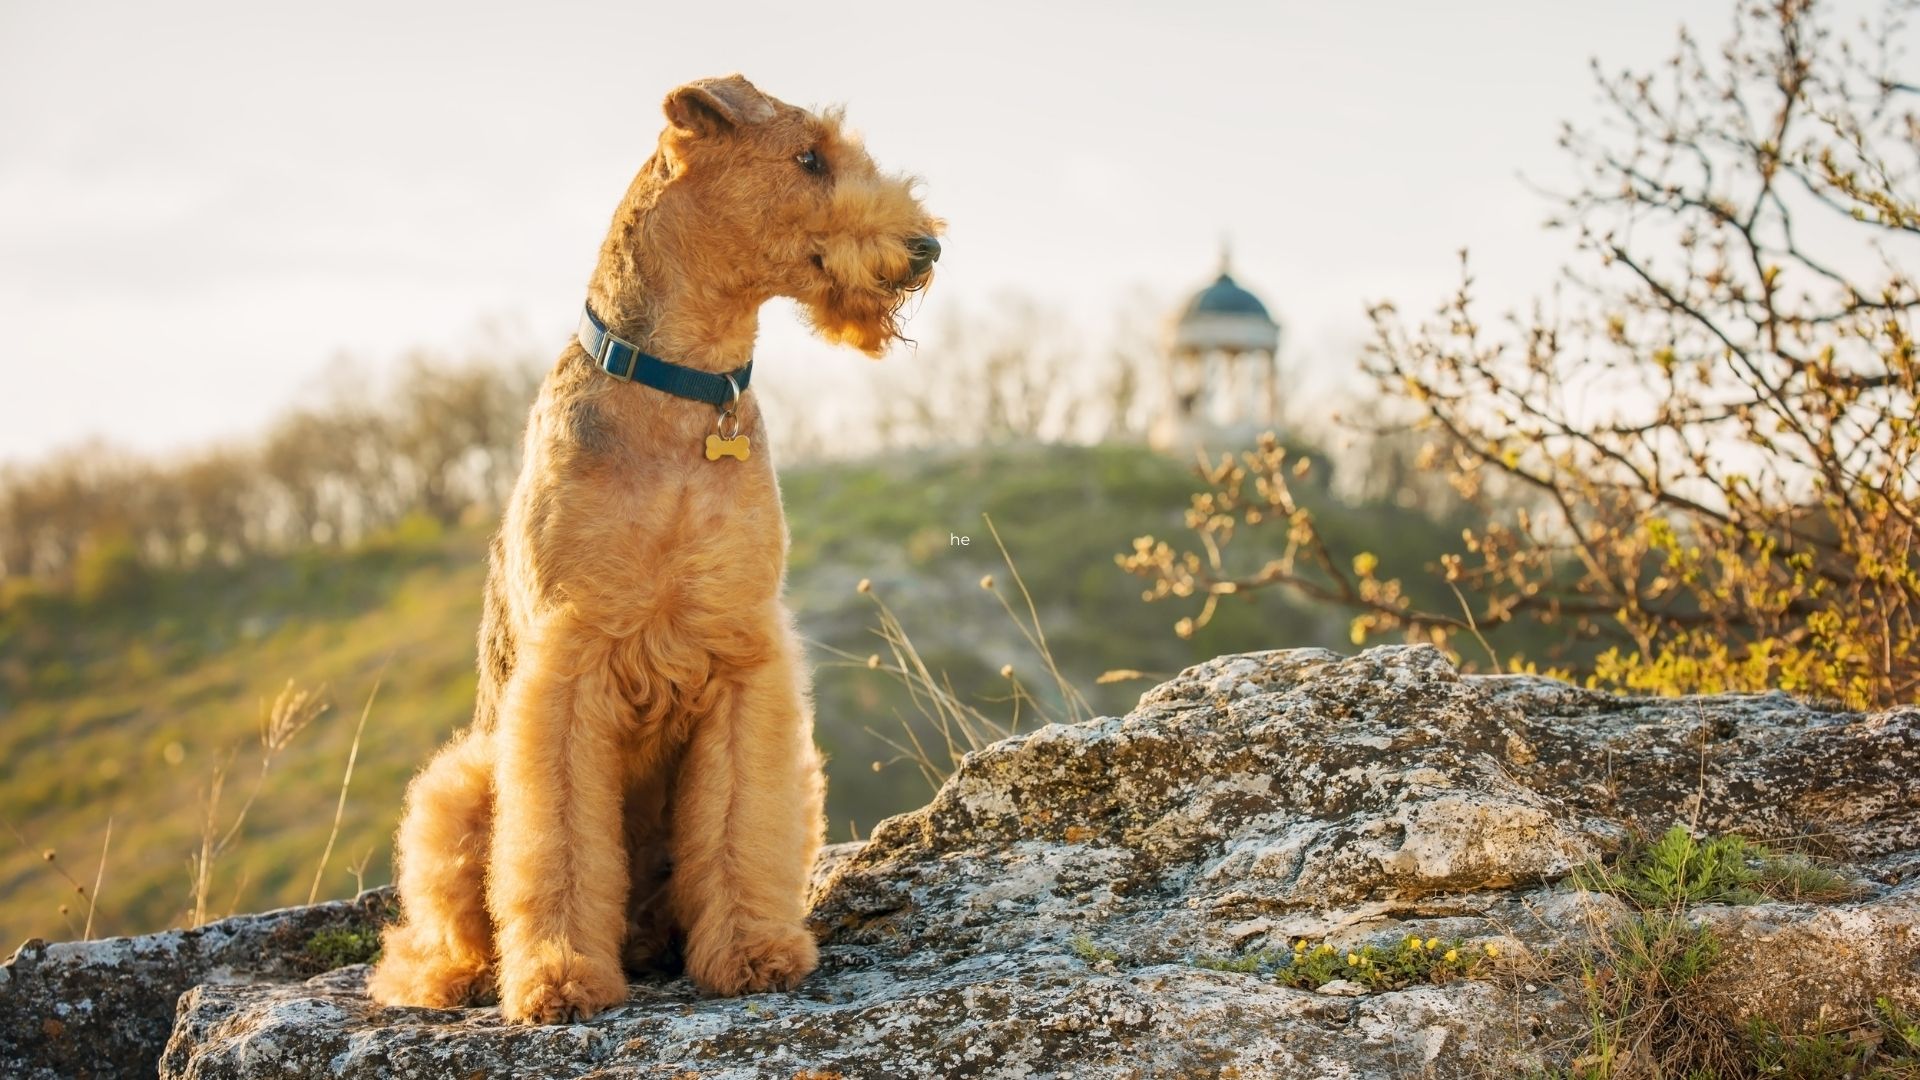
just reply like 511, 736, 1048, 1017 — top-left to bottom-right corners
0, 0, 1889, 461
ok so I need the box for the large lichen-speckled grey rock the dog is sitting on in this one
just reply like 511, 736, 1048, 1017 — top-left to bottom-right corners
0, 648, 1920, 1078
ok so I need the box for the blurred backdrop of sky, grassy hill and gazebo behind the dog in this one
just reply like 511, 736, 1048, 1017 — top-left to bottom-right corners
0, 0, 1912, 944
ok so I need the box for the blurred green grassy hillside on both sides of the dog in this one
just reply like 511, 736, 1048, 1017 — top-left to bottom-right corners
0, 438, 1457, 945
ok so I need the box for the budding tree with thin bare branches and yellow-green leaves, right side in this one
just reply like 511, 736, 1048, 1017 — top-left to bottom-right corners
1121, 0, 1920, 705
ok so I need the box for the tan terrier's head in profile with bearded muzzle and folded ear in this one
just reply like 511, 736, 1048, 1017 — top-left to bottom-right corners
651, 75, 945, 356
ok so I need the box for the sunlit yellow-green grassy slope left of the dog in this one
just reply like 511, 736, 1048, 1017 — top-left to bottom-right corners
0, 532, 484, 949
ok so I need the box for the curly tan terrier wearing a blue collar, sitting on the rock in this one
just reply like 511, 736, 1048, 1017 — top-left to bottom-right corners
369, 75, 943, 1022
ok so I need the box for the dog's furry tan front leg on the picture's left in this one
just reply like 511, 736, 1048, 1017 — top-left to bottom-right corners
488, 625, 628, 1024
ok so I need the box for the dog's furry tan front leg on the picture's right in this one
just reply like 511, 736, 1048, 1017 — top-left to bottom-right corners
668, 619, 824, 995
